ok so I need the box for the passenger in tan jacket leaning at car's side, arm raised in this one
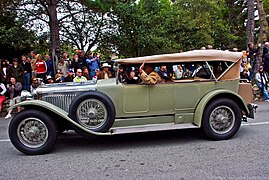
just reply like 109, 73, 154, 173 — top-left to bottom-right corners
139, 61, 162, 85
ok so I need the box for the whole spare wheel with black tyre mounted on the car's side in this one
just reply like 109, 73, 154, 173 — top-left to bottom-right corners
69, 91, 116, 134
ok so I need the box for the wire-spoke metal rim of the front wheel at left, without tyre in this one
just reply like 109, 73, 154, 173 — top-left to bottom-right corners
17, 118, 48, 148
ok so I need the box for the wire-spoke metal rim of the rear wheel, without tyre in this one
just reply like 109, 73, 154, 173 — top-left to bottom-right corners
209, 106, 235, 134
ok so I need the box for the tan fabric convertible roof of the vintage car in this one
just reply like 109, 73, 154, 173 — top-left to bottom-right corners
116, 50, 243, 64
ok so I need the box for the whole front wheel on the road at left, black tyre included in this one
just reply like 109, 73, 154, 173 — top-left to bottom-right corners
9, 110, 57, 155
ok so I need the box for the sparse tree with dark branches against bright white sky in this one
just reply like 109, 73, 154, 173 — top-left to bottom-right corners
59, 1, 114, 51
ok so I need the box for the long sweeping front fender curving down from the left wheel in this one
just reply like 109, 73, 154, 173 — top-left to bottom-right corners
8, 100, 112, 135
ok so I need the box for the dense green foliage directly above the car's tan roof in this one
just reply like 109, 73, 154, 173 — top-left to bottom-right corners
97, 0, 246, 57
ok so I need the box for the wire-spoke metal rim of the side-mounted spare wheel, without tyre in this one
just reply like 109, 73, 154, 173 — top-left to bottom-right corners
77, 99, 107, 129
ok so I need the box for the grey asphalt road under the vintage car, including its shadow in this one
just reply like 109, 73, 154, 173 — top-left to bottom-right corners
0, 102, 269, 180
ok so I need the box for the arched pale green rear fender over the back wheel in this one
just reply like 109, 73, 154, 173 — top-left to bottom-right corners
193, 89, 249, 127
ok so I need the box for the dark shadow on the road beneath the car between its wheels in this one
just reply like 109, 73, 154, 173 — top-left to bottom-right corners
54, 129, 204, 153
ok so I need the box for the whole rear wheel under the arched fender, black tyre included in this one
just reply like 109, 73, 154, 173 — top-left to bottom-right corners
202, 98, 242, 140
